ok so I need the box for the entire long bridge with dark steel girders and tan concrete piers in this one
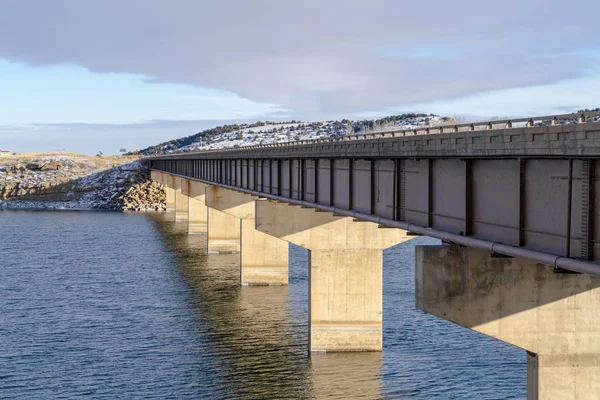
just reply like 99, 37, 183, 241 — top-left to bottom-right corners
149, 113, 600, 399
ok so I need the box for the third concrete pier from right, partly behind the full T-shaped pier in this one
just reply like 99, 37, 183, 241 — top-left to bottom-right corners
206, 186, 289, 285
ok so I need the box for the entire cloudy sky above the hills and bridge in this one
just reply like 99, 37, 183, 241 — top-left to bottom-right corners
0, 0, 600, 154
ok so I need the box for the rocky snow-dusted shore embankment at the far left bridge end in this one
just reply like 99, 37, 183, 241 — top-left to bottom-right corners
0, 154, 166, 211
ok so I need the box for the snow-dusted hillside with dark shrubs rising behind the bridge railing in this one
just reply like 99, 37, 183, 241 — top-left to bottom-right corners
135, 113, 453, 155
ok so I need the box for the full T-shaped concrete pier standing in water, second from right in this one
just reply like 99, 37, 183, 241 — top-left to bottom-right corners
256, 201, 409, 351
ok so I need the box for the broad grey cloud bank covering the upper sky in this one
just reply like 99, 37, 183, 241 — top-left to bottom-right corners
0, 0, 600, 118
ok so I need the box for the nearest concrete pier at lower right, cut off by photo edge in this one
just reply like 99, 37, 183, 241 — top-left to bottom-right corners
416, 246, 600, 400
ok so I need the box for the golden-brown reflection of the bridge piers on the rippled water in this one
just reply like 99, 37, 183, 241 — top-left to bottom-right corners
152, 215, 382, 399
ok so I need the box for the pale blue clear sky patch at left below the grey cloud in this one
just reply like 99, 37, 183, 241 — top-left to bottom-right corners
0, 59, 280, 125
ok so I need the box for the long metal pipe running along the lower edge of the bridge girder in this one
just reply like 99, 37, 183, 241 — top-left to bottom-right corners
158, 170, 600, 276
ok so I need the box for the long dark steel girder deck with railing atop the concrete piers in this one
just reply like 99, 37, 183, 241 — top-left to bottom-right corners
149, 115, 600, 273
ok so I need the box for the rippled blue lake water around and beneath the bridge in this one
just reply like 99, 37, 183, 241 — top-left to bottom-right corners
0, 211, 526, 399
